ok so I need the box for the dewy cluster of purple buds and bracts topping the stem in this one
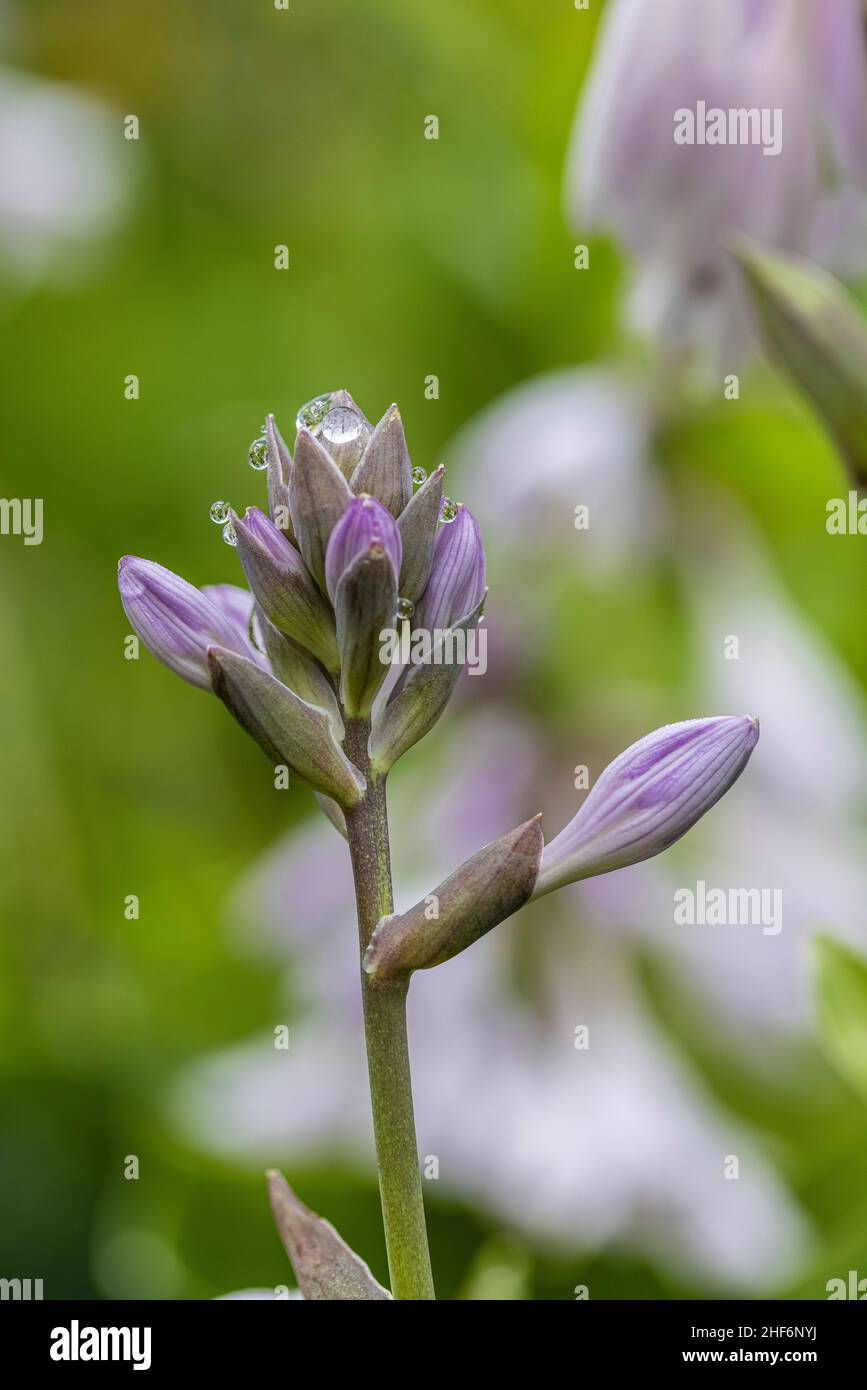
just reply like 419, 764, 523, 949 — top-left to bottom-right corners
118, 392, 485, 795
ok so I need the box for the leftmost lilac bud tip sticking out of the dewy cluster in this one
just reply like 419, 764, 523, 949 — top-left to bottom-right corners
118, 555, 250, 689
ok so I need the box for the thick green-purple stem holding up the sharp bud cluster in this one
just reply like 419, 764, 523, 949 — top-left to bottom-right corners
345, 720, 435, 1298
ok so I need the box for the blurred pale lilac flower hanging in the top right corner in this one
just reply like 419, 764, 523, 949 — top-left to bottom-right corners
565, 0, 867, 360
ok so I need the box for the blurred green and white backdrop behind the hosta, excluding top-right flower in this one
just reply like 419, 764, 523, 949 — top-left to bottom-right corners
0, 0, 867, 1298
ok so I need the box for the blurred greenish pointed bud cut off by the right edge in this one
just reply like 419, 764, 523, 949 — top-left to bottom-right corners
734, 239, 867, 484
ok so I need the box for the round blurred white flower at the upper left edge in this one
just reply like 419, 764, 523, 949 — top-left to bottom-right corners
0, 67, 138, 284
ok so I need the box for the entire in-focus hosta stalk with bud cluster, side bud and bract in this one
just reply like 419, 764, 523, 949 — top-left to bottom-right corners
119, 392, 757, 1300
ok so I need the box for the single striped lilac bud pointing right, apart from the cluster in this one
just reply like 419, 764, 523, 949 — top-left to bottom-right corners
534, 714, 759, 898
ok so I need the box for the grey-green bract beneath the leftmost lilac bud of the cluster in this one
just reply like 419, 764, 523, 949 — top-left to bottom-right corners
208, 646, 365, 808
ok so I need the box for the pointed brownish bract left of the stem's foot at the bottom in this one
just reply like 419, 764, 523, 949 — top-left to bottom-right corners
265, 1170, 392, 1302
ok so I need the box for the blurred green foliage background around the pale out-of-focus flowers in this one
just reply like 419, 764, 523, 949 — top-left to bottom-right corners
0, 0, 867, 1298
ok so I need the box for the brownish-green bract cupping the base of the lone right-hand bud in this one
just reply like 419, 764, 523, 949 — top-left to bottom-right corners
364, 816, 542, 980
